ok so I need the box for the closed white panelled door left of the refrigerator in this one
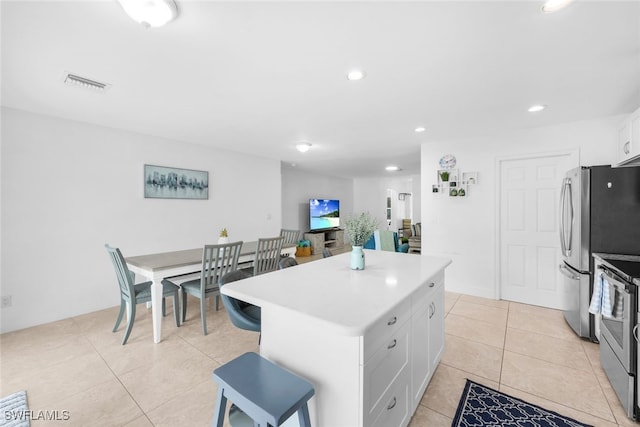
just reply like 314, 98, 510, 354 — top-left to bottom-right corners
499, 152, 578, 309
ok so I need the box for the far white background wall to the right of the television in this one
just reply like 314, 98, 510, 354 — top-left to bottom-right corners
353, 175, 422, 231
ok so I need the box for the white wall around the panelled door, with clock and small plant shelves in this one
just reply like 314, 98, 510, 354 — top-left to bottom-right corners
421, 116, 623, 298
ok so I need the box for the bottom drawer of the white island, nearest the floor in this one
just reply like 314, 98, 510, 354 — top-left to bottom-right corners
365, 368, 411, 427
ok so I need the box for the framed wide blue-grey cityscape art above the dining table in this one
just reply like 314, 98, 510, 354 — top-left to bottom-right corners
144, 165, 209, 200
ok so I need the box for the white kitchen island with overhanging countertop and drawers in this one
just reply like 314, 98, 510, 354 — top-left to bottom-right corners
222, 250, 451, 427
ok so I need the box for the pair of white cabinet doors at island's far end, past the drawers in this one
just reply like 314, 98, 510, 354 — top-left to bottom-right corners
411, 274, 444, 411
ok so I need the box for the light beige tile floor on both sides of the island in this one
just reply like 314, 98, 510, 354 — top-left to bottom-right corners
0, 282, 637, 427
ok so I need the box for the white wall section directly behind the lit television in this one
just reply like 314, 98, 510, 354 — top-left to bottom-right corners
282, 164, 353, 233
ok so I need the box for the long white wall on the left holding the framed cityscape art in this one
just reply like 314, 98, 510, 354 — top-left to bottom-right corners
1, 108, 282, 332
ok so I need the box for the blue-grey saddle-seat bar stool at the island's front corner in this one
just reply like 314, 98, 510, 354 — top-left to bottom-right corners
213, 353, 315, 427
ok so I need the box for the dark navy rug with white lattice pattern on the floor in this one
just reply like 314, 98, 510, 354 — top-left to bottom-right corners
451, 380, 592, 427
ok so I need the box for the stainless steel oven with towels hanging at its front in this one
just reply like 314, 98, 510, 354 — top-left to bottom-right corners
594, 258, 638, 418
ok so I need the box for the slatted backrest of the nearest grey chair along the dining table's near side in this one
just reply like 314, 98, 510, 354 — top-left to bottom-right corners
200, 241, 242, 297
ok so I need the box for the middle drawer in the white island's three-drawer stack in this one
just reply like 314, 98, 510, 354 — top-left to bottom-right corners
363, 322, 411, 425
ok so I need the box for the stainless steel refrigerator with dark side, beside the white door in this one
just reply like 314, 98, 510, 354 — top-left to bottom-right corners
559, 166, 640, 341
